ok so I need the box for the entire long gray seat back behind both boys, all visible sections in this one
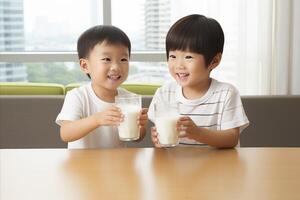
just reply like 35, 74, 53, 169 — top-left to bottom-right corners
0, 95, 300, 148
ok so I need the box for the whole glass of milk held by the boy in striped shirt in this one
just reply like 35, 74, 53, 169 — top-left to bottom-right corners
154, 102, 180, 147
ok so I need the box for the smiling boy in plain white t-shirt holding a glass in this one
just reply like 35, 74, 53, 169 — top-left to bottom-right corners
56, 26, 148, 148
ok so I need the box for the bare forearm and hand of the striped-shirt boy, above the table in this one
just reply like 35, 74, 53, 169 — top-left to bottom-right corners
177, 117, 240, 148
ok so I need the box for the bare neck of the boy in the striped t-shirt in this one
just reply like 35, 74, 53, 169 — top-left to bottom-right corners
182, 78, 212, 100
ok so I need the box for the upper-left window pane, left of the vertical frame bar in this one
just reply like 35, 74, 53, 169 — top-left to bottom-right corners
0, 0, 102, 51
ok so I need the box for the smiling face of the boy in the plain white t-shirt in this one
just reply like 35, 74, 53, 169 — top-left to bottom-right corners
80, 41, 129, 90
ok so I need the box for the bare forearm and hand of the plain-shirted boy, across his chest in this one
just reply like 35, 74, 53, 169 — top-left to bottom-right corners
60, 106, 124, 142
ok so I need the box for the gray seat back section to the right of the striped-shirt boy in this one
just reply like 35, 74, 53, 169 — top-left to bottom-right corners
240, 95, 300, 147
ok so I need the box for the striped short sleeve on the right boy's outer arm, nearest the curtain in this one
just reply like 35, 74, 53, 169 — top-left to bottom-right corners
221, 88, 249, 132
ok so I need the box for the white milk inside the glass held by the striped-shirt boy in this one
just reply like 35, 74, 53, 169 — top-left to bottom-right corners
155, 114, 179, 146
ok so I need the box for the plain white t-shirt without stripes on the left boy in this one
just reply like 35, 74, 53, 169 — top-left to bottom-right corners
56, 83, 132, 149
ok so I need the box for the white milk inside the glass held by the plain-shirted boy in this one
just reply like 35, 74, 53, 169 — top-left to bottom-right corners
118, 105, 140, 141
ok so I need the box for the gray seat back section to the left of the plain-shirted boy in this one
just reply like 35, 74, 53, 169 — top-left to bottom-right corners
0, 95, 67, 148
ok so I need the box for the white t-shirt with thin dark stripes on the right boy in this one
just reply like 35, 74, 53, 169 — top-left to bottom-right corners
148, 79, 249, 145
